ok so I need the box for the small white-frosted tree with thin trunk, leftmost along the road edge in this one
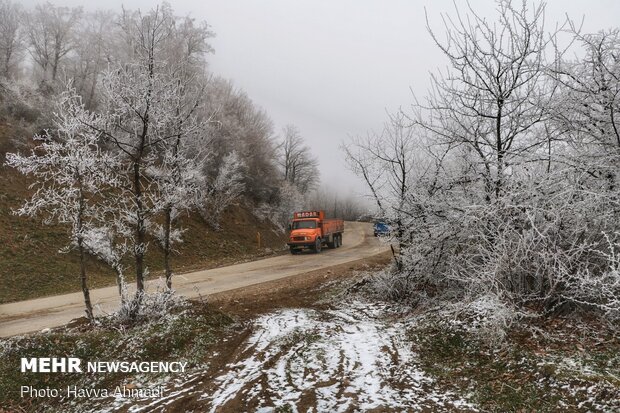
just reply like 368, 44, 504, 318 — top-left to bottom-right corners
7, 92, 116, 320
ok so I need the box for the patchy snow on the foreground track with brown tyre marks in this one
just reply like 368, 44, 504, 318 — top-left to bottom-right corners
200, 302, 475, 412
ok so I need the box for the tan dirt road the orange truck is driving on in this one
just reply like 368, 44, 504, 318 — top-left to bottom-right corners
0, 222, 386, 337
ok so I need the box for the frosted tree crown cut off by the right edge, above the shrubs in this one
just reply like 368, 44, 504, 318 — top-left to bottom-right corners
551, 29, 620, 191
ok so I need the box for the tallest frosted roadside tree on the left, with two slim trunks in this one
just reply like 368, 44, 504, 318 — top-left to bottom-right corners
75, 4, 217, 303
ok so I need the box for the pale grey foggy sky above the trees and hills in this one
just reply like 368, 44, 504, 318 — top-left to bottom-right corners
23, 0, 620, 198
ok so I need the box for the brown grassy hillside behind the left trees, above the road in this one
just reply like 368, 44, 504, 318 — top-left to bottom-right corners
0, 121, 285, 303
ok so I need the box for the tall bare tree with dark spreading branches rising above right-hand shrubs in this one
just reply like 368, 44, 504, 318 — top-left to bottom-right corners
412, 0, 554, 202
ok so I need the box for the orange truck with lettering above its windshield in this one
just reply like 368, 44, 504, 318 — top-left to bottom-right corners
287, 211, 344, 254
